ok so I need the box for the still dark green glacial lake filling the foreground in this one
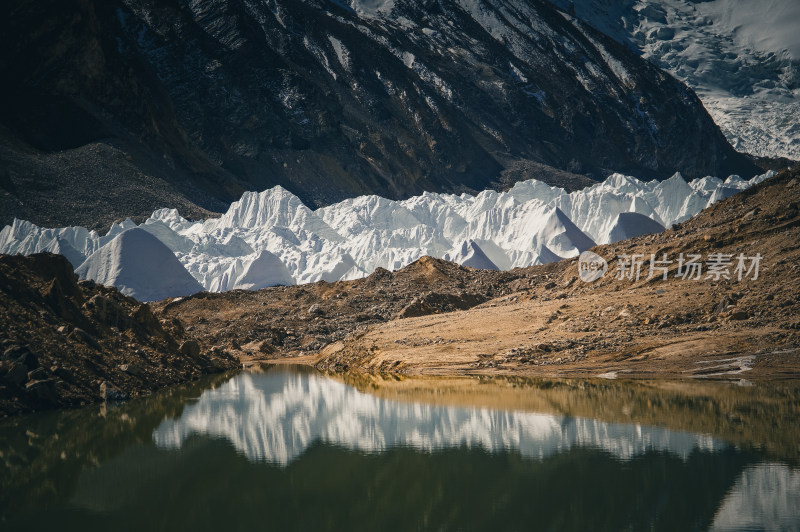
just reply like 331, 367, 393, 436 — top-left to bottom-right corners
0, 367, 800, 531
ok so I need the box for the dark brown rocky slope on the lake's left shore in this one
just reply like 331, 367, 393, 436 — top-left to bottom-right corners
0, 253, 238, 417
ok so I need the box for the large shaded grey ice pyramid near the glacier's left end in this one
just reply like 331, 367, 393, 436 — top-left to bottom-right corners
75, 228, 203, 301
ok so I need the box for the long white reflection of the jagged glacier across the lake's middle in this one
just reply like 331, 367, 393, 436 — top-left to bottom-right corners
153, 373, 721, 464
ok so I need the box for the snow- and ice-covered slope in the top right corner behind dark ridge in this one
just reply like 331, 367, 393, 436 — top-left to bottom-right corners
553, 0, 800, 160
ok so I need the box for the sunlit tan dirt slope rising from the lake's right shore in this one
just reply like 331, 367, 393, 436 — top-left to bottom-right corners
317, 168, 800, 379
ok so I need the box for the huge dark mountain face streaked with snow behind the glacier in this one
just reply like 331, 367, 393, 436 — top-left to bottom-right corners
0, 0, 753, 227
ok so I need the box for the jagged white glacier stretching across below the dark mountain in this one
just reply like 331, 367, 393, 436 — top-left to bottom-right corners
0, 172, 775, 301
